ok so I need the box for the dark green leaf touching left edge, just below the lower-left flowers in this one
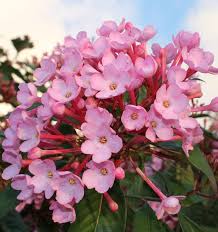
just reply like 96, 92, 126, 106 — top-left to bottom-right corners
0, 187, 17, 218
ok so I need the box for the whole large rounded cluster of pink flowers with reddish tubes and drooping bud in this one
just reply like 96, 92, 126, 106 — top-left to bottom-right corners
2, 20, 218, 223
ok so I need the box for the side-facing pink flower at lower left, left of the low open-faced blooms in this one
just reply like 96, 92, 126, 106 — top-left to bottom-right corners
11, 174, 33, 201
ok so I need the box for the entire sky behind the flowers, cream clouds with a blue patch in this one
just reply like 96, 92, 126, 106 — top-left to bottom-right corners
0, 0, 218, 114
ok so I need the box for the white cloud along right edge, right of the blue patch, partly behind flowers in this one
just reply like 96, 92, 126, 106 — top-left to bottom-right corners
186, 0, 218, 102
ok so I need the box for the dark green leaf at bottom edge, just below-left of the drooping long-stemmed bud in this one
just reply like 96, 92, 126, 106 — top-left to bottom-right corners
133, 205, 170, 232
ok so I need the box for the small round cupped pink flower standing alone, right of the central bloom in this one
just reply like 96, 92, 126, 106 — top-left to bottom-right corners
121, 105, 147, 130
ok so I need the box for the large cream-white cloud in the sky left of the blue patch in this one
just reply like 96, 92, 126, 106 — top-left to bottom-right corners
0, 0, 137, 55
